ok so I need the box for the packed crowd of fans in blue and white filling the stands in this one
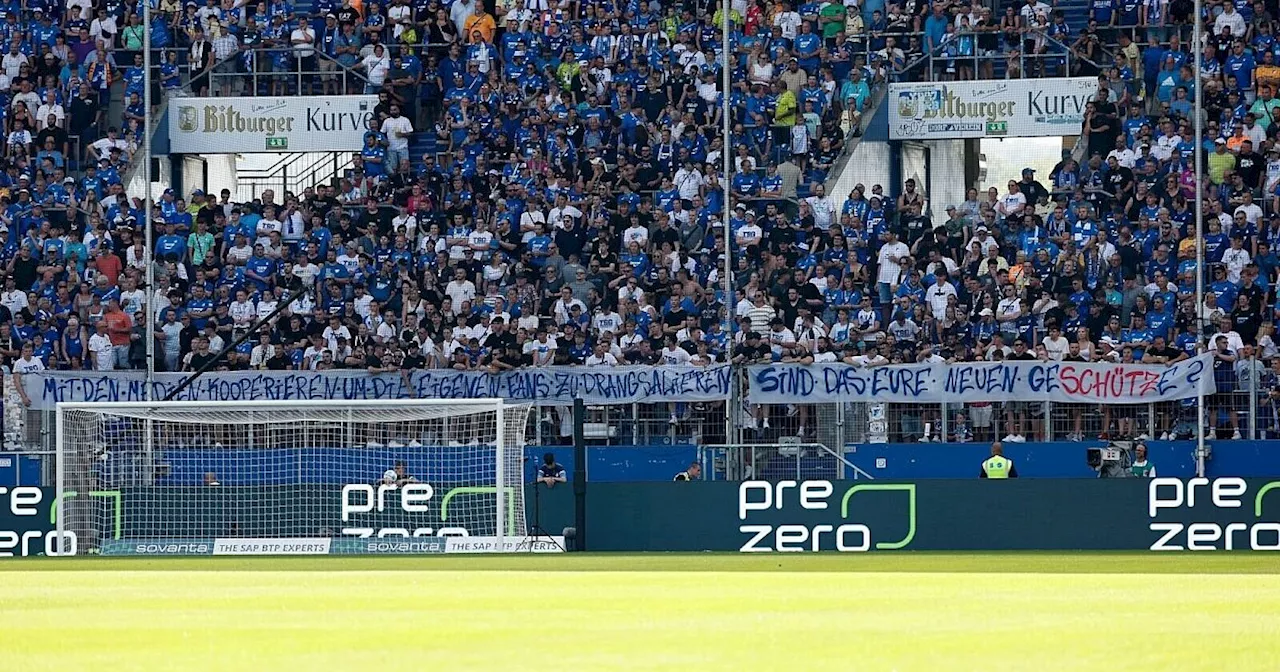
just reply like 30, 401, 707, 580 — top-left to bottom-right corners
0, 0, 1280, 442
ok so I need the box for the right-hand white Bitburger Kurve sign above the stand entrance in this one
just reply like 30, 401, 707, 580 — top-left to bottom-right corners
888, 77, 1098, 140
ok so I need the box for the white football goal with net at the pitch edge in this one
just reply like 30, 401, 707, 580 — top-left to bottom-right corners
54, 399, 529, 554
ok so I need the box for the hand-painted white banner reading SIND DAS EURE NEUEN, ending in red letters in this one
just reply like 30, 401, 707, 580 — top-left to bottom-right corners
749, 355, 1217, 403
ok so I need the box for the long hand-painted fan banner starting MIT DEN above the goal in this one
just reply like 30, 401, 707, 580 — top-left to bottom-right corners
22, 365, 731, 408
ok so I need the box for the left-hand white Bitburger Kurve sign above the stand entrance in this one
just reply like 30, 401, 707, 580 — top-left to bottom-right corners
169, 96, 378, 154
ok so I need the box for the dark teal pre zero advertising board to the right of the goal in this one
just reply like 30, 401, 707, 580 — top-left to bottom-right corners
578, 479, 1280, 553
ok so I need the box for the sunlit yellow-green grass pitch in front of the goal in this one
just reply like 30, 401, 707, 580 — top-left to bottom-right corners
0, 553, 1280, 672
